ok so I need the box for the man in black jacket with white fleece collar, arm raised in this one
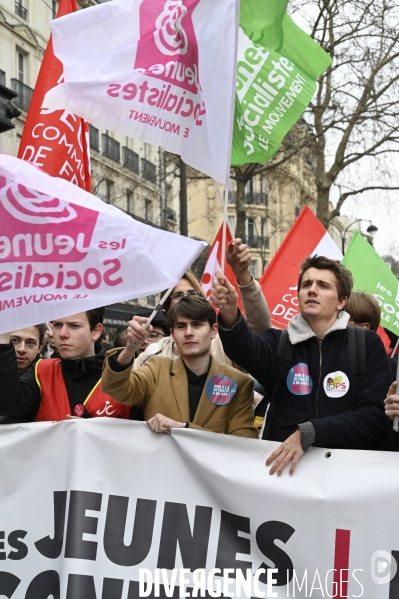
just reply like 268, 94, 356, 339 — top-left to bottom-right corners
211, 256, 391, 474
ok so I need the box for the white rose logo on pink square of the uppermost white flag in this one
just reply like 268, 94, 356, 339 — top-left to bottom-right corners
154, 0, 188, 56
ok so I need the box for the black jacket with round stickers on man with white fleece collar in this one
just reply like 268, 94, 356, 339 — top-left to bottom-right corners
219, 317, 392, 449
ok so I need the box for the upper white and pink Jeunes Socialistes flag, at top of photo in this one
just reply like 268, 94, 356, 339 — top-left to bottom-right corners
43, 0, 239, 183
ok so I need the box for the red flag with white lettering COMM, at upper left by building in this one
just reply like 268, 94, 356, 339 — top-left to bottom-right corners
18, 0, 91, 191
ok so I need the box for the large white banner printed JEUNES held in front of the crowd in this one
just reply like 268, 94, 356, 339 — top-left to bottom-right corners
0, 418, 399, 599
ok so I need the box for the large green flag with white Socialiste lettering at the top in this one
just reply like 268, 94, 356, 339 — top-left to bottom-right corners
231, 0, 332, 165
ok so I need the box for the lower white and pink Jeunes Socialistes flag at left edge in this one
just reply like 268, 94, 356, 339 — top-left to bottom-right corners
0, 154, 205, 332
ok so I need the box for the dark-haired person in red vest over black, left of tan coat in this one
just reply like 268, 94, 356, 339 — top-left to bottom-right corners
0, 308, 130, 422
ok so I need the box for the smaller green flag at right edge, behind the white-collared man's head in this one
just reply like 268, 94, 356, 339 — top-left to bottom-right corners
342, 231, 399, 335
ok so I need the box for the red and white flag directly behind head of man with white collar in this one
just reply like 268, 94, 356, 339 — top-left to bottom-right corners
259, 206, 342, 329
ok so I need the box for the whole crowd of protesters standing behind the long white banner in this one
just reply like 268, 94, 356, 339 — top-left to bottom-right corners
0, 239, 399, 474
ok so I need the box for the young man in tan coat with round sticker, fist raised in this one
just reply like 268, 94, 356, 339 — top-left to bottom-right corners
102, 296, 258, 439
